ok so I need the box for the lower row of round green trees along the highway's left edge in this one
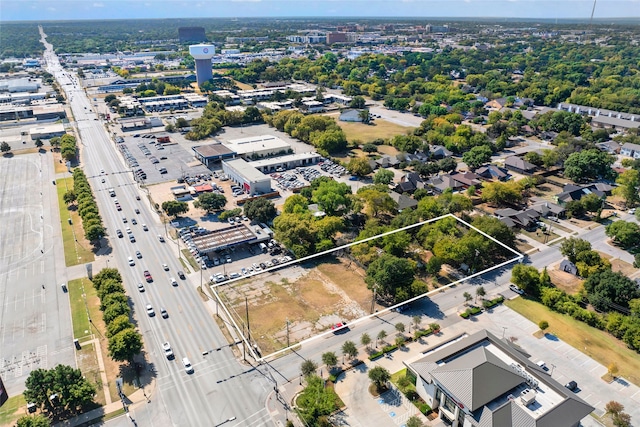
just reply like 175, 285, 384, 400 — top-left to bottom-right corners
92, 268, 142, 362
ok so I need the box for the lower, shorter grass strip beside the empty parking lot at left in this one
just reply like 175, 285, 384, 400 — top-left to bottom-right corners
67, 278, 102, 341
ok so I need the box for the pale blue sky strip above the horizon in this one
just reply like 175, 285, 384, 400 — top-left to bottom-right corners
0, 0, 640, 21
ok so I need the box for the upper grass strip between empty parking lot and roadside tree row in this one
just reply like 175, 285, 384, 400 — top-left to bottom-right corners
56, 178, 95, 267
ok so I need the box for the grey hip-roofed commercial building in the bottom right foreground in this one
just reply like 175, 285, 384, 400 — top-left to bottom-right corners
406, 330, 594, 427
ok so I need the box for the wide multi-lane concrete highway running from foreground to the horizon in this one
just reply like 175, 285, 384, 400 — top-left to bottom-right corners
40, 28, 272, 426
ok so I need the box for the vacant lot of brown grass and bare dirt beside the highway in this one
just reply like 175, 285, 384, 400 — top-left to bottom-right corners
218, 259, 372, 354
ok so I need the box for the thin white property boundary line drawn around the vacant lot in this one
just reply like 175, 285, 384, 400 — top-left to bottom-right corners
209, 213, 525, 362
